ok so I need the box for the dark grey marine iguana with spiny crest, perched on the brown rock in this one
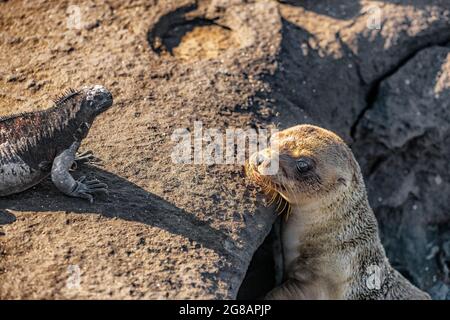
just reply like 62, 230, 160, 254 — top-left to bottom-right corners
0, 85, 113, 203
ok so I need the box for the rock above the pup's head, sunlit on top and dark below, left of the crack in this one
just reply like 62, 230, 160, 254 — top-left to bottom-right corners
264, 1, 450, 142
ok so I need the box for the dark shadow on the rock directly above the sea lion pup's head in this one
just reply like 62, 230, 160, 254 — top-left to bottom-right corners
260, 18, 369, 141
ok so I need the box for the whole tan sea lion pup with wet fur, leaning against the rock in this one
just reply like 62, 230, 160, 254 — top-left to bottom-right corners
246, 125, 430, 299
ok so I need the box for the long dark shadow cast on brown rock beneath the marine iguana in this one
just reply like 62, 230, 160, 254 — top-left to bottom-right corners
0, 166, 232, 253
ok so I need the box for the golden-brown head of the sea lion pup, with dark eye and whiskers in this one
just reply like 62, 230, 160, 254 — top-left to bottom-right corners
246, 125, 360, 210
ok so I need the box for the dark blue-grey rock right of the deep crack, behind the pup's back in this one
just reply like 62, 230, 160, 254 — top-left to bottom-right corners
353, 47, 450, 298
